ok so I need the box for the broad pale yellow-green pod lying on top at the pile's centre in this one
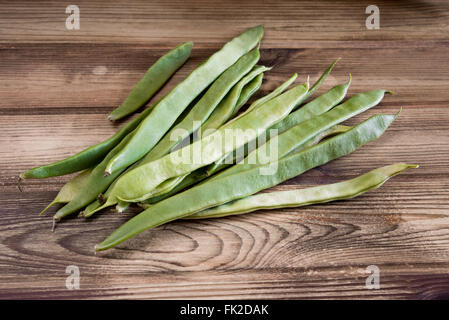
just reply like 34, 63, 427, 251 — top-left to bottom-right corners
108, 84, 308, 202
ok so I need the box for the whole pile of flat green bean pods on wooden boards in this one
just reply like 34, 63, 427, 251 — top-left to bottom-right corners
19, 26, 418, 251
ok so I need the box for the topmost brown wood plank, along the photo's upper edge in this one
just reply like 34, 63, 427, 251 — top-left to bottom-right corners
0, 0, 449, 48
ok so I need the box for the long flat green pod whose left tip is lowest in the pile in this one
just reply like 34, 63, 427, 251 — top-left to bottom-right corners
96, 115, 396, 251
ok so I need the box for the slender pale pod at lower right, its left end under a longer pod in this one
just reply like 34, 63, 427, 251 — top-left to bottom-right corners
184, 163, 418, 219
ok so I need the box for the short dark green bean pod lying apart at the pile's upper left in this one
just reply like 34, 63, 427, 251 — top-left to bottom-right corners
108, 41, 193, 121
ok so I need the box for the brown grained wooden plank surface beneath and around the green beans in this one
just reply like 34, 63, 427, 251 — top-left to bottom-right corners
0, 0, 449, 299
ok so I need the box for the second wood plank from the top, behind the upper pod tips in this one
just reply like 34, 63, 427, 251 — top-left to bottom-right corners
0, 45, 449, 110
